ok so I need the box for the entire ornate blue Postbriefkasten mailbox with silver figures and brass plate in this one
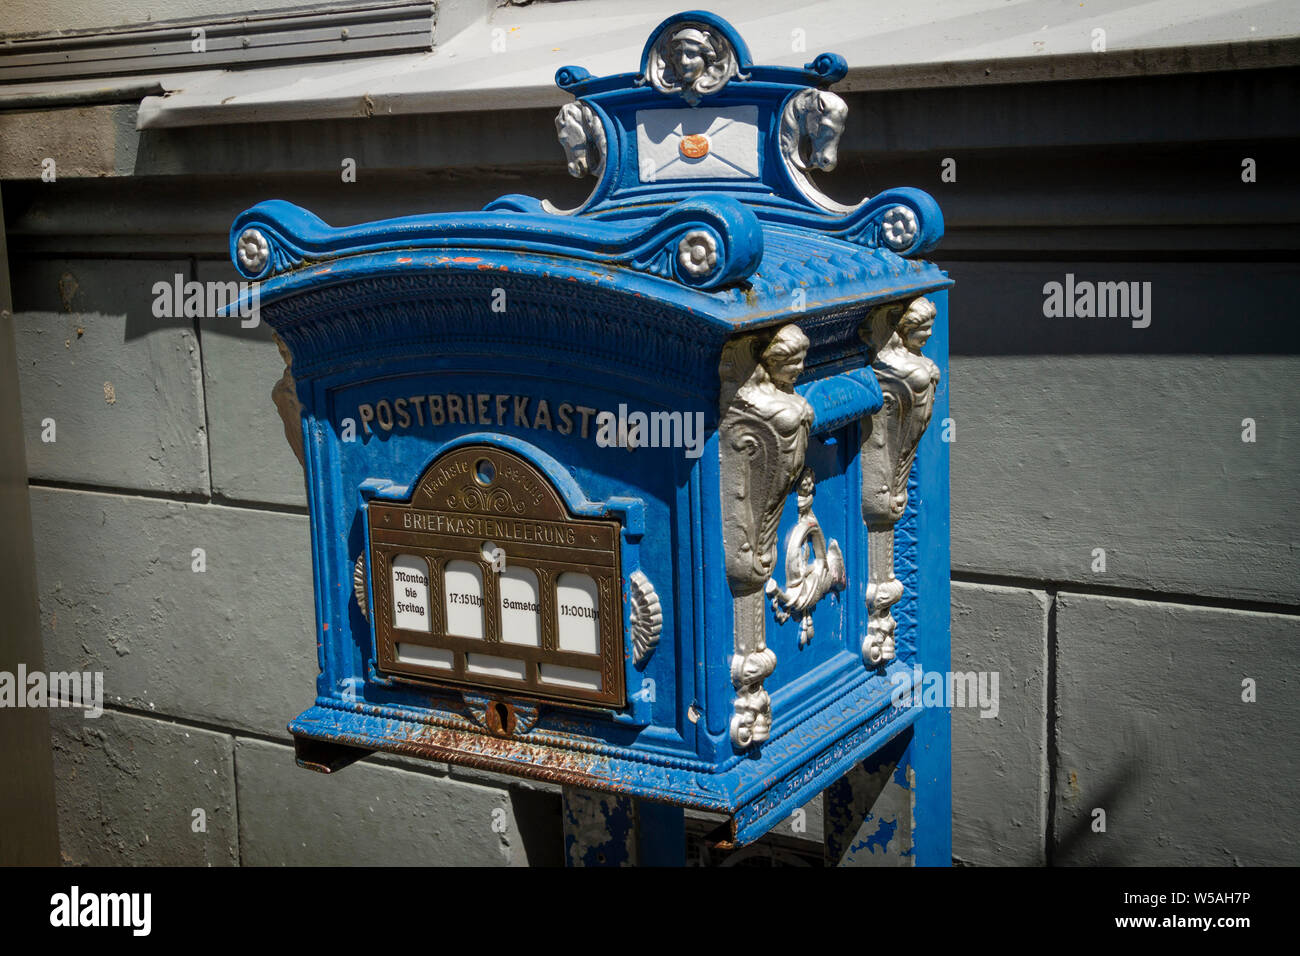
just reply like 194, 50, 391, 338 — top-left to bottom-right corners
230, 12, 950, 862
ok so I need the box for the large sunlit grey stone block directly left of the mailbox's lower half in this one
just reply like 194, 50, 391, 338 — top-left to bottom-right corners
31, 488, 319, 736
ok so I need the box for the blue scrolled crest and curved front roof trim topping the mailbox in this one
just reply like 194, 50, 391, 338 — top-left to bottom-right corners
231, 10, 944, 290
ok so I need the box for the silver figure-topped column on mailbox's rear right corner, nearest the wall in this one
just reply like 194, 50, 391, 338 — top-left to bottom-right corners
859, 298, 940, 666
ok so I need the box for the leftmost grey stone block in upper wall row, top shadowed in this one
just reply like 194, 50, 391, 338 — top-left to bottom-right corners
14, 259, 208, 496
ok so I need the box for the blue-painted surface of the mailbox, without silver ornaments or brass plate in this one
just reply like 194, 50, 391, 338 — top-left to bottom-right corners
245, 12, 952, 861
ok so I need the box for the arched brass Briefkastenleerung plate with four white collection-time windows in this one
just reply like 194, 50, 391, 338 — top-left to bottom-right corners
368, 445, 627, 708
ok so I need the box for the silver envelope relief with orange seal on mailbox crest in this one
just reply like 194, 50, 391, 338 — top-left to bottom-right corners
637, 107, 759, 182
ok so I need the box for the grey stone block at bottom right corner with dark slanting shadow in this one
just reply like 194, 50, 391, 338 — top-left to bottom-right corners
1053, 593, 1300, 866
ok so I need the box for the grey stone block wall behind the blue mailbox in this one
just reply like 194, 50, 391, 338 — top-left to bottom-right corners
0, 59, 1300, 865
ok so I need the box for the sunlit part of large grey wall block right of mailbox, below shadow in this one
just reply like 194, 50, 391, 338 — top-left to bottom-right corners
948, 356, 1300, 605
